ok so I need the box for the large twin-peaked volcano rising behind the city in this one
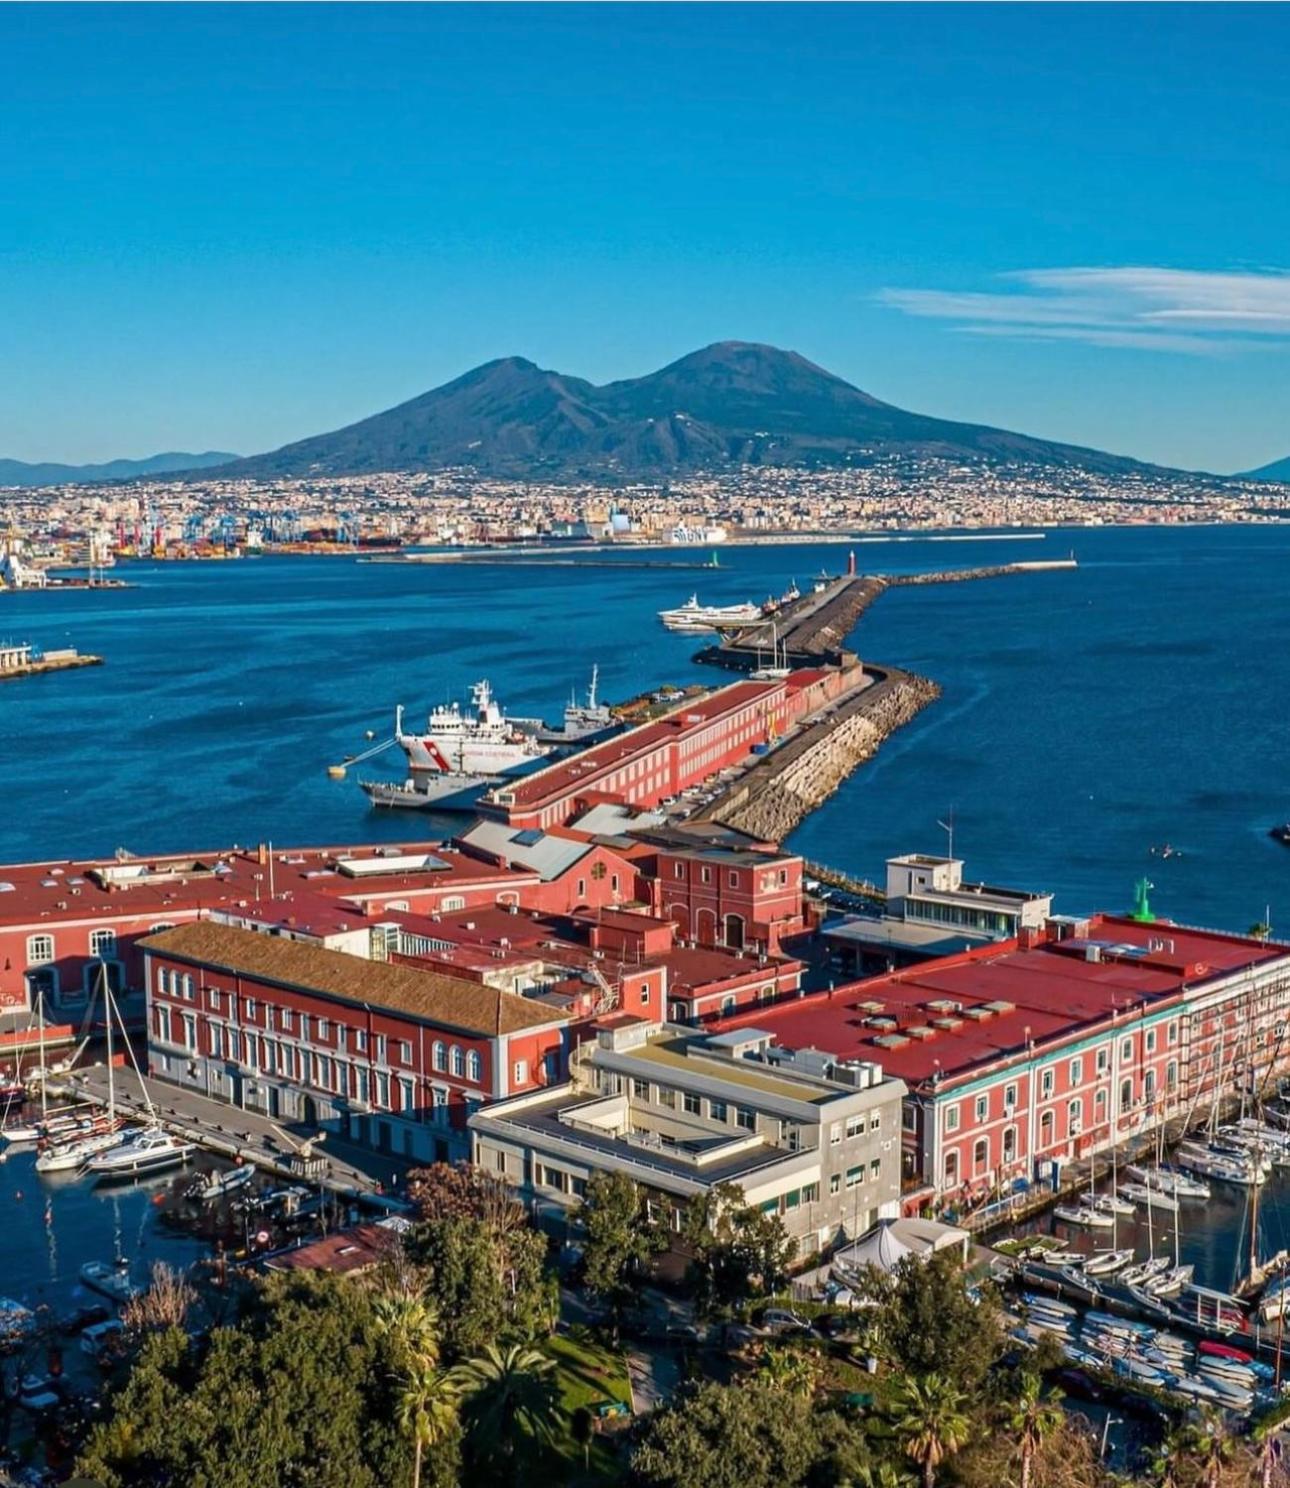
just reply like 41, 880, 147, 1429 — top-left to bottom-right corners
186, 341, 1184, 479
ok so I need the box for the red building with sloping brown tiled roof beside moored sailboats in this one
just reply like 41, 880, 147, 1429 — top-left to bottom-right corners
143, 921, 570, 1161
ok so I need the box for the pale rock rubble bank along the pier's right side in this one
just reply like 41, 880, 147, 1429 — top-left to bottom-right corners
692, 668, 940, 842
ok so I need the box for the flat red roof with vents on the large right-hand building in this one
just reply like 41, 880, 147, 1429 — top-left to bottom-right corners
720, 917, 1287, 1085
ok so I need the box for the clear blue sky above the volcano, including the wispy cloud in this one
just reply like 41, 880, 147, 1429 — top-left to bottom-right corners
0, 4, 1290, 470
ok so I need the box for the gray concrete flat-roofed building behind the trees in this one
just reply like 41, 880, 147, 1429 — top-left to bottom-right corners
470, 1016, 905, 1256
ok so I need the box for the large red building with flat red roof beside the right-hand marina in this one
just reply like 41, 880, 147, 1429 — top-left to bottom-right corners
711, 915, 1290, 1205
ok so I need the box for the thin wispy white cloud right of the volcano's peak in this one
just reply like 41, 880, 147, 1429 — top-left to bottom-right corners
878, 266, 1290, 356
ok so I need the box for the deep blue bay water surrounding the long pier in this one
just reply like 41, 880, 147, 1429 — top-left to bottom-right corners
0, 527, 1290, 930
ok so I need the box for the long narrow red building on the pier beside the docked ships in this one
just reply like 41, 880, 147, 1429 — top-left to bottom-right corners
484, 667, 863, 830
